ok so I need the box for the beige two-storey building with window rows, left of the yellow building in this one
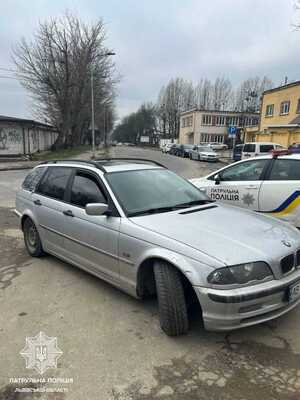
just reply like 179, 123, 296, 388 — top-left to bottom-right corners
179, 109, 259, 144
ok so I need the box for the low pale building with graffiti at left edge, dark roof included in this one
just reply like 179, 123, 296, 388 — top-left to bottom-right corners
0, 115, 57, 157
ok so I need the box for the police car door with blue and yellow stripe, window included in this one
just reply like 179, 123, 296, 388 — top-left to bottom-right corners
259, 158, 300, 227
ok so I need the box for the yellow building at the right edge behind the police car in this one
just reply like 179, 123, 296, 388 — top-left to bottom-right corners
256, 81, 300, 147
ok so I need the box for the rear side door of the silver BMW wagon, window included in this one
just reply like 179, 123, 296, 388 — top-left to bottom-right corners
32, 166, 73, 256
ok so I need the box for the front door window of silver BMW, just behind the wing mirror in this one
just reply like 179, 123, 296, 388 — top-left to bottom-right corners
71, 173, 107, 207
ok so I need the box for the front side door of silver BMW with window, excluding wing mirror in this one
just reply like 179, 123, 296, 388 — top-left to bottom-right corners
64, 169, 120, 284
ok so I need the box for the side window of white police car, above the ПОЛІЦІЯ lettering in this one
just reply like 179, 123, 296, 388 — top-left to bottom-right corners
220, 160, 269, 181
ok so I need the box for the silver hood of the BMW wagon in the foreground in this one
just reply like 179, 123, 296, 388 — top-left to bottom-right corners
131, 204, 300, 265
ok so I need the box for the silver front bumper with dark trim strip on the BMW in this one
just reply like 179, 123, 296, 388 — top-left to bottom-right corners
194, 269, 300, 331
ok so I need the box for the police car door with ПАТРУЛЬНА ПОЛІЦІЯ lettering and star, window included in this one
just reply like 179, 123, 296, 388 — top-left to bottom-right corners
206, 158, 271, 210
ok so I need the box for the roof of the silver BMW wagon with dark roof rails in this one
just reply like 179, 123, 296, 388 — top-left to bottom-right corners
39, 158, 166, 173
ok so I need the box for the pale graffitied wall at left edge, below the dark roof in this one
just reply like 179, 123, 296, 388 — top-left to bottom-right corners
0, 123, 57, 156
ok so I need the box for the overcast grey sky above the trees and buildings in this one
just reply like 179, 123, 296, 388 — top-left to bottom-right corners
0, 0, 300, 121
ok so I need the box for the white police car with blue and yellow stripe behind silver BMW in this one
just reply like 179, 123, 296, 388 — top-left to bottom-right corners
191, 150, 300, 228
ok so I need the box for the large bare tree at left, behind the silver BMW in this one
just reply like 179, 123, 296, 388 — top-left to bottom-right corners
12, 13, 117, 147
